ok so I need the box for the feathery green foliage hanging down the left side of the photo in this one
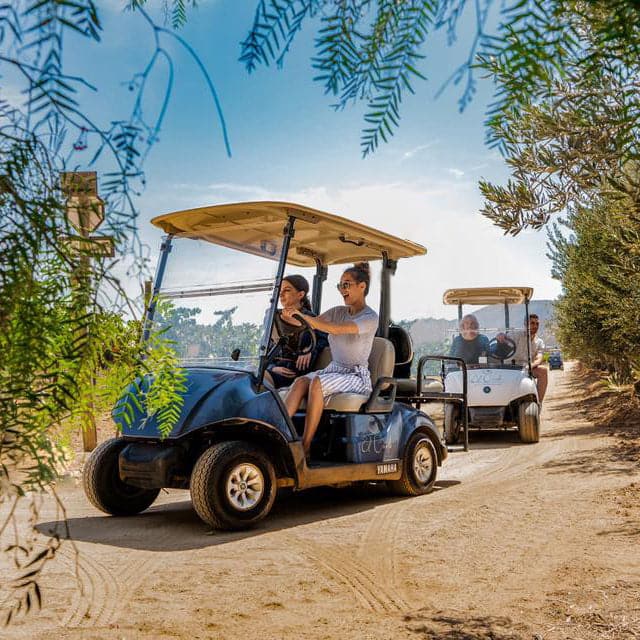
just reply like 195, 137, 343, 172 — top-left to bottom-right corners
0, 0, 224, 623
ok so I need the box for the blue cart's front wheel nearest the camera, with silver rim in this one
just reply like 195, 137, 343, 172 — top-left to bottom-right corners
191, 441, 276, 530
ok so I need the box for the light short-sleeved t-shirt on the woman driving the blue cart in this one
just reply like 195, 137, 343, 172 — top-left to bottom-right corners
318, 306, 378, 367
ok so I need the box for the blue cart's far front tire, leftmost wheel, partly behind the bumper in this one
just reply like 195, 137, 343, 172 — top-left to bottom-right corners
82, 438, 160, 516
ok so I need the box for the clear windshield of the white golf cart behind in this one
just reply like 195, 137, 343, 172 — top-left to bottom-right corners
447, 304, 529, 368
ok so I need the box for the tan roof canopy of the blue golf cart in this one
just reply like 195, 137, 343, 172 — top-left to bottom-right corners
151, 202, 427, 267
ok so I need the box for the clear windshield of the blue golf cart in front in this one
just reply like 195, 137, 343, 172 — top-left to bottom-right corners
154, 238, 281, 372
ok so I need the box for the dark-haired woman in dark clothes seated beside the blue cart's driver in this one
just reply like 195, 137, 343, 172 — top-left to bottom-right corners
267, 275, 328, 389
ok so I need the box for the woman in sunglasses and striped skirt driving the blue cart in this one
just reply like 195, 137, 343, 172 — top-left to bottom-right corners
282, 262, 378, 456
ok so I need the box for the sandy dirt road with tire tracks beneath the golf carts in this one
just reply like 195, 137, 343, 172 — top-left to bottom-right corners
0, 362, 640, 640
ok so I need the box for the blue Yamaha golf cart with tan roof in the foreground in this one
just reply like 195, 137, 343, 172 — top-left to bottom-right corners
84, 202, 447, 529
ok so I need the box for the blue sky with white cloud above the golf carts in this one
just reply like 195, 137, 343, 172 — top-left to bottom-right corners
58, 0, 559, 318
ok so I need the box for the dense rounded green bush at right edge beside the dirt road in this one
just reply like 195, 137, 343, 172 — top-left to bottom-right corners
550, 188, 640, 382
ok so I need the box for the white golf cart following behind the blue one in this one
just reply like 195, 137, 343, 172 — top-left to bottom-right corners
443, 287, 540, 444
